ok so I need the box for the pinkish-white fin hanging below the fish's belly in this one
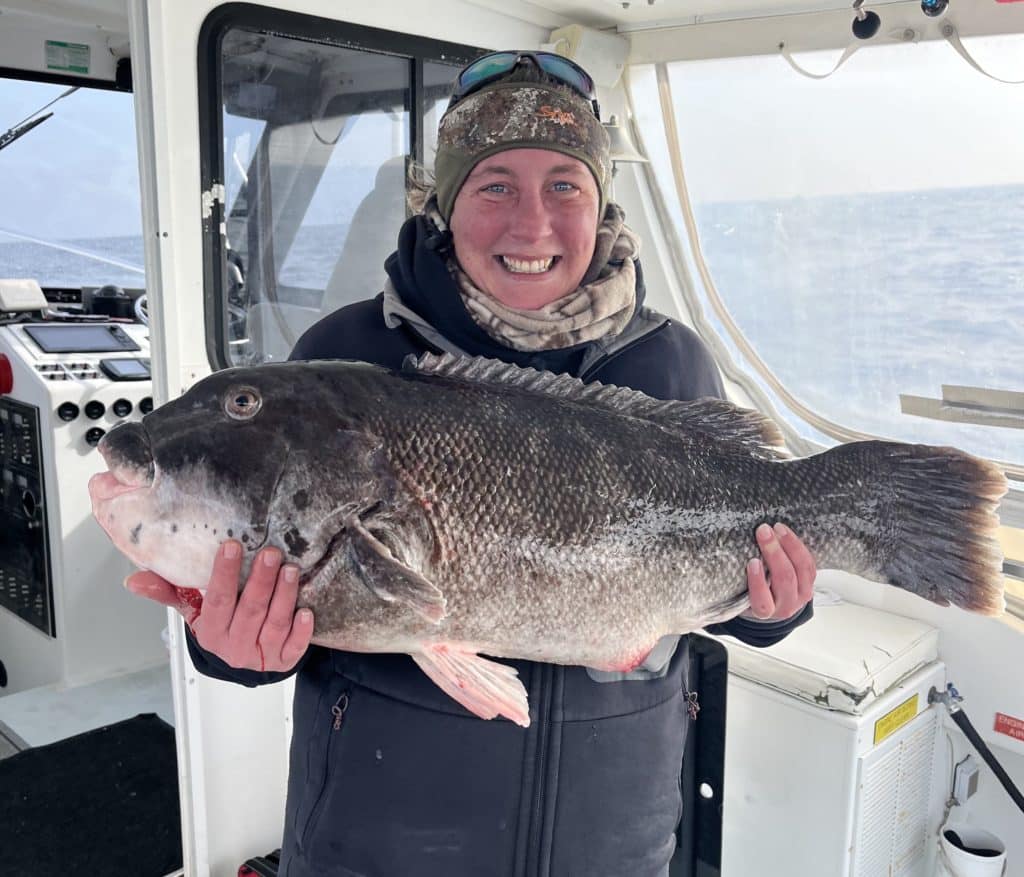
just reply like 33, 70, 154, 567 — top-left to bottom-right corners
413, 643, 529, 727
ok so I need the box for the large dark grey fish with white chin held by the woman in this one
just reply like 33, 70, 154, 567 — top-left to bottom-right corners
89, 354, 1007, 725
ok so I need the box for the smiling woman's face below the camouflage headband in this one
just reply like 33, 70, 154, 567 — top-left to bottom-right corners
449, 150, 600, 310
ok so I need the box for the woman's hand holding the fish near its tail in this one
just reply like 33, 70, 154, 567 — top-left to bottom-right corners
743, 524, 817, 621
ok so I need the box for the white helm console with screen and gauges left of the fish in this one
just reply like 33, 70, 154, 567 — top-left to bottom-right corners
0, 321, 165, 694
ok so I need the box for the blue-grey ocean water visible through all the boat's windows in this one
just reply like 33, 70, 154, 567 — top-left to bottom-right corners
0, 185, 1024, 462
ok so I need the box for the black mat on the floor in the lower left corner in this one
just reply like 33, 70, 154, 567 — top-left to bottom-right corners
0, 713, 181, 877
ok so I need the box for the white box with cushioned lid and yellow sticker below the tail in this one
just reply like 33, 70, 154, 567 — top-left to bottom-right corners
720, 592, 946, 877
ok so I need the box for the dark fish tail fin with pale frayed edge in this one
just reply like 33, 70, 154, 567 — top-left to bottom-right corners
874, 442, 1008, 615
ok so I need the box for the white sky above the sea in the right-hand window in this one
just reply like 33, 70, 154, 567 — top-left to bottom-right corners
631, 36, 1024, 201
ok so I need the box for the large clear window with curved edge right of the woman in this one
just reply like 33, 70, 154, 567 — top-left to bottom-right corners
631, 35, 1024, 471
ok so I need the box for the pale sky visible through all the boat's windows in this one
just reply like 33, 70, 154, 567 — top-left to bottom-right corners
0, 36, 1024, 241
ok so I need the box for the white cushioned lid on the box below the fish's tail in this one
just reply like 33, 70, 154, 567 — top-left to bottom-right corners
720, 590, 939, 715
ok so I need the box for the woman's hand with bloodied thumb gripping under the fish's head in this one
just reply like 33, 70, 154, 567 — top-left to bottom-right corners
125, 540, 313, 672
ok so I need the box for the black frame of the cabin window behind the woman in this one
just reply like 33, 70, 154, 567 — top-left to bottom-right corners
197, 3, 486, 371
